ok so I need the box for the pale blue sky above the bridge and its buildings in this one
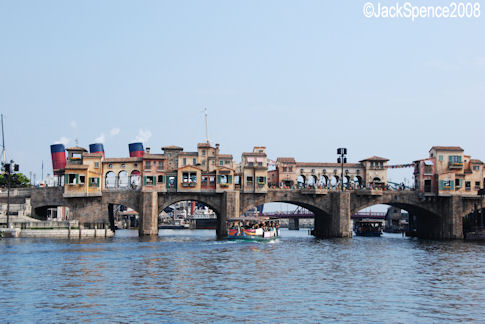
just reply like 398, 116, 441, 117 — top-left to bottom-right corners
0, 0, 485, 182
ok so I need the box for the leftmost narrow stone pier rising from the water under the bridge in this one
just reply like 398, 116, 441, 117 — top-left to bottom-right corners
138, 191, 158, 236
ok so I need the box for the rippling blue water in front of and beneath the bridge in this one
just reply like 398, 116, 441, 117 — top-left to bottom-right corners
0, 230, 485, 323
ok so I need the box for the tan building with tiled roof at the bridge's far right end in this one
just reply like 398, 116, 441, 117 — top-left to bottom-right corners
414, 146, 485, 196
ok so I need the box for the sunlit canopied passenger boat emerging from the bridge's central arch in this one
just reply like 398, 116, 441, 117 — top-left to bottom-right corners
227, 217, 280, 240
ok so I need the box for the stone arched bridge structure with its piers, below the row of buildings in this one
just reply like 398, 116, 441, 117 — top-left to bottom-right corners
27, 187, 483, 239
